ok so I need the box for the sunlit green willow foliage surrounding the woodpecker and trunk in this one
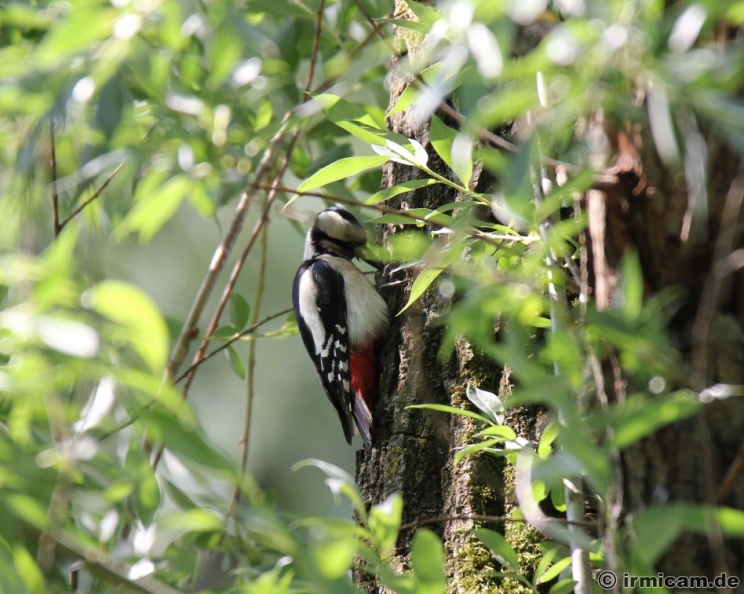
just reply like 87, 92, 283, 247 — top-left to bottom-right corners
0, 0, 744, 594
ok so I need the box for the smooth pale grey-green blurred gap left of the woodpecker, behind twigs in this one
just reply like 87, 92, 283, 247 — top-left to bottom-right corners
106, 198, 362, 518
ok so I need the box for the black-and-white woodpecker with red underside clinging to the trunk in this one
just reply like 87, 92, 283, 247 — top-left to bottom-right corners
292, 206, 388, 449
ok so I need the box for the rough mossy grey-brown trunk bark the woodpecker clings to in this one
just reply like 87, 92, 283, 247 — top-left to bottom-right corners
356, 2, 536, 594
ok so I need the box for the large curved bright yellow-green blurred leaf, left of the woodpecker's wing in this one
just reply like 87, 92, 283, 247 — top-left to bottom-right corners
86, 280, 168, 375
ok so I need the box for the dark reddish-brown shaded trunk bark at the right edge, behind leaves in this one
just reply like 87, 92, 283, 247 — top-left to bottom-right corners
587, 115, 744, 577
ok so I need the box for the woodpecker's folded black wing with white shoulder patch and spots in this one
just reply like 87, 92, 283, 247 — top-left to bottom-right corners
292, 260, 354, 443
